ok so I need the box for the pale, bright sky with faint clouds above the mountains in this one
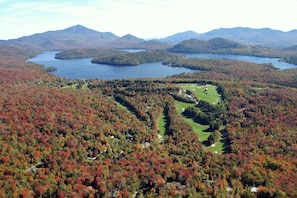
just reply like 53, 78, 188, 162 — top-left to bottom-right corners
0, 0, 297, 40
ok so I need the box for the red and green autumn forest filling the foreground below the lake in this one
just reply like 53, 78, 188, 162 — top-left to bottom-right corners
0, 47, 297, 197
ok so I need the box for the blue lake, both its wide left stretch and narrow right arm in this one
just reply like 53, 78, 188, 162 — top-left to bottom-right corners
28, 51, 297, 80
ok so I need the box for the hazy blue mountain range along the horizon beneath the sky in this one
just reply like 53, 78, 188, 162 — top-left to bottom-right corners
0, 25, 297, 50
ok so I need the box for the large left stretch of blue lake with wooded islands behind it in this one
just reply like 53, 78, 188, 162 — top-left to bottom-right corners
28, 51, 199, 80
